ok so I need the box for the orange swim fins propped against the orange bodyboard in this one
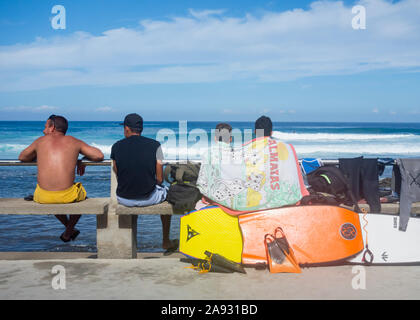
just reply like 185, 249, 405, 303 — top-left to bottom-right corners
264, 227, 302, 273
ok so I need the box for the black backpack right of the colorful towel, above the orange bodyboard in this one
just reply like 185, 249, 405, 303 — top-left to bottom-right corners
307, 166, 360, 212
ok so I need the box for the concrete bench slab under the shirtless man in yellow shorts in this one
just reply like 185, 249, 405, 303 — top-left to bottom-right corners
0, 198, 109, 215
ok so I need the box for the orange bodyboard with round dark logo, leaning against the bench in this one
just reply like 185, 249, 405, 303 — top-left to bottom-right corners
238, 205, 364, 265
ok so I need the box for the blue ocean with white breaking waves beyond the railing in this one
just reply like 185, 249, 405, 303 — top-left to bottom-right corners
0, 121, 420, 252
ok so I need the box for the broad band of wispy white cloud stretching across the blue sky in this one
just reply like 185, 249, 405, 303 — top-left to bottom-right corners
0, 0, 420, 91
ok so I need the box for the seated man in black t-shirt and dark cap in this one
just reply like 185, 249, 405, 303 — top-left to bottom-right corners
111, 113, 178, 251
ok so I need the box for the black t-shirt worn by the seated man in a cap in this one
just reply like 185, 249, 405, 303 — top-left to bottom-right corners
111, 135, 163, 199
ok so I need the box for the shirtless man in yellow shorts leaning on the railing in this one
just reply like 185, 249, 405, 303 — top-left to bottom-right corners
19, 115, 104, 242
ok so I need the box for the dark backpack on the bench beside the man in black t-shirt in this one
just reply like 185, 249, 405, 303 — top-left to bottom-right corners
164, 162, 202, 214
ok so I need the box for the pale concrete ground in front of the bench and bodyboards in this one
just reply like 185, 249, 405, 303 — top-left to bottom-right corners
0, 253, 420, 300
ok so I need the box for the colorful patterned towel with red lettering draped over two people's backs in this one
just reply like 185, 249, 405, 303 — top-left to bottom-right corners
197, 137, 309, 211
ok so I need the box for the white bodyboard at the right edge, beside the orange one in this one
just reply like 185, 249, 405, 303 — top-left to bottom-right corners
349, 213, 420, 264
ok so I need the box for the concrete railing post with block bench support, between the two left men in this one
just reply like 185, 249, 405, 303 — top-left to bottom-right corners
96, 161, 137, 259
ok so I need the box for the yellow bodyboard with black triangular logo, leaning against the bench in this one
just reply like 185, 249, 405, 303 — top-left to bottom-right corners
179, 206, 243, 263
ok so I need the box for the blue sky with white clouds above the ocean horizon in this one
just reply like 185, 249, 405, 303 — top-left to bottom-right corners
0, 0, 420, 122
